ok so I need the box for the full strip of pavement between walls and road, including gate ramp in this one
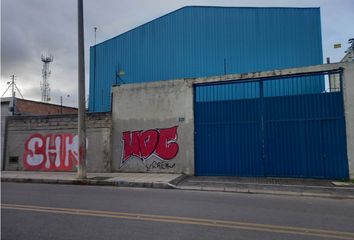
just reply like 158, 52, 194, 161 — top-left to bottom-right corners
1, 171, 354, 199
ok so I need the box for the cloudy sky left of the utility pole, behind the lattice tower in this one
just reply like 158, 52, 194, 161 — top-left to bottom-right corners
1, 0, 77, 103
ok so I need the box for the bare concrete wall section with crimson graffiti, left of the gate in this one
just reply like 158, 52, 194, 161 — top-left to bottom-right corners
112, 80, 194, 175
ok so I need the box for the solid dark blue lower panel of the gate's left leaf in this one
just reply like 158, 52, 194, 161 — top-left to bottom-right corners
195, 96, 264, 176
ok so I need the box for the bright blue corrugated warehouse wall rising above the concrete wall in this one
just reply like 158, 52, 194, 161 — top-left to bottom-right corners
89, 7, 324, 112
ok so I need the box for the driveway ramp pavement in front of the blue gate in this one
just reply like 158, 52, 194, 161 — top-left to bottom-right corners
175, 176, 354, 199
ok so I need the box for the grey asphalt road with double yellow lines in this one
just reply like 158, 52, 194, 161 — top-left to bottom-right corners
1, 183, 354, 240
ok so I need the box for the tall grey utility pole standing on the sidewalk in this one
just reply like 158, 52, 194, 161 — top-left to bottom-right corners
77, 0, 86, 179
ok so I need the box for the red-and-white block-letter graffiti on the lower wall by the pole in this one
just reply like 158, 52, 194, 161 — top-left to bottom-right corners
23, 133, 83, 171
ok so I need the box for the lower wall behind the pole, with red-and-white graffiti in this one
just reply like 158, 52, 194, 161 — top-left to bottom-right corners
5, 113, 112, 172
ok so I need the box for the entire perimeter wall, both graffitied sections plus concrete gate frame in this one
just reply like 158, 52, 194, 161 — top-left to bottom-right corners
4, 63, 354, 178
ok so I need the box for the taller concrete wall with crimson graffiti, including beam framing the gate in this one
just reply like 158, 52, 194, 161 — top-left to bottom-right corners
112, 63, 354, 178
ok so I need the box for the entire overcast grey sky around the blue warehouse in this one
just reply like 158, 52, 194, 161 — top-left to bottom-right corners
0, 0, 354, 106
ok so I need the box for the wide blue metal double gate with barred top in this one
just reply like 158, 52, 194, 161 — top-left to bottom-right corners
194, 72, 349, 179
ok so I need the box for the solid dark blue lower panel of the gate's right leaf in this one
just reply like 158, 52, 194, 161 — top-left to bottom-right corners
263, 92, 348, 179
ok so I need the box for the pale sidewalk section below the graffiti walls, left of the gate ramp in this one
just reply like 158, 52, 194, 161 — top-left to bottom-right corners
1, 171, 184, 188
